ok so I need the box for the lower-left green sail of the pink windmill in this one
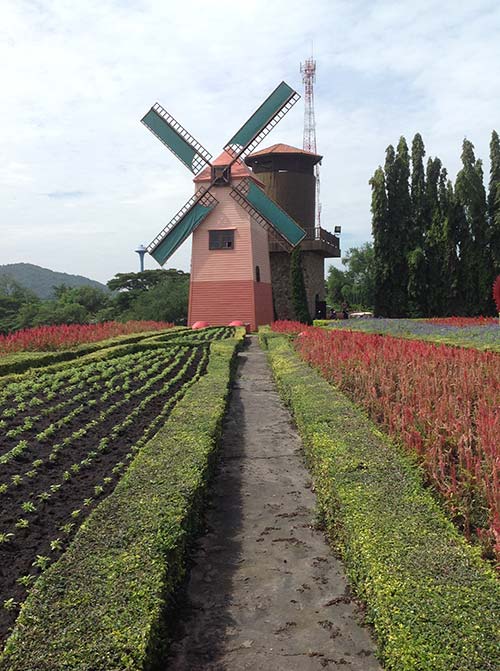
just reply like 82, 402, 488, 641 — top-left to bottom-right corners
148, 188, 219, 266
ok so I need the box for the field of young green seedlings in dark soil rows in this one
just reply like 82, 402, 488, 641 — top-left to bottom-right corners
0, 323, 233, 652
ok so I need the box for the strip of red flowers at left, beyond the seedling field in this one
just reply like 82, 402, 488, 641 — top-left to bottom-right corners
0, 321, 173, 355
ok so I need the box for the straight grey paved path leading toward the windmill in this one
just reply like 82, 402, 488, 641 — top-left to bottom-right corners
166, 338, 381, 671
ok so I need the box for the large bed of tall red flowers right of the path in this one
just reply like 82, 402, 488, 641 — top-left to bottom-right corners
273, 324, 500, 558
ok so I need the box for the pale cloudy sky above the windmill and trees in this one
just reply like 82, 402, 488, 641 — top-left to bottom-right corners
0, 0, 500, 282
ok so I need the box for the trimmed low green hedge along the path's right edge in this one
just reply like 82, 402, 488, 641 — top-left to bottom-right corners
261, 333, 500, 671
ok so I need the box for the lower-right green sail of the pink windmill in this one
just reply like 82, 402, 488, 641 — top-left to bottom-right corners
231, 178, 306, 250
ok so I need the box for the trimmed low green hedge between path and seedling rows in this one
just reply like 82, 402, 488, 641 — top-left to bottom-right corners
0, 329, 244, 671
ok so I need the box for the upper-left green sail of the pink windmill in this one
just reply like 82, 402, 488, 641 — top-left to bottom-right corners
141, 103, 212, 175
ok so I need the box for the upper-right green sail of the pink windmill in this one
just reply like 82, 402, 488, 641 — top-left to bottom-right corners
224, 82, 300, 163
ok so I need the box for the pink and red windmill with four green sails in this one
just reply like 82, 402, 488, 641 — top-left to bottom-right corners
141, 82, 305, 329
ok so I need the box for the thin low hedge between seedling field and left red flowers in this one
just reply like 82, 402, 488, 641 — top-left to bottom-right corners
0, 327, 182, 382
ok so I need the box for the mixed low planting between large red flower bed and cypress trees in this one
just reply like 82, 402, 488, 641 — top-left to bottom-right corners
316, 317, 500, 352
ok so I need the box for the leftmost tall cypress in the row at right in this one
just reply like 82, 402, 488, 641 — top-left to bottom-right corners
370, 167, 394, 317
